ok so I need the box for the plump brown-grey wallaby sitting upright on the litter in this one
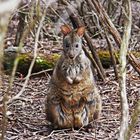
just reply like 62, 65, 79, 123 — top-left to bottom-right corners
45, 25, 101, 128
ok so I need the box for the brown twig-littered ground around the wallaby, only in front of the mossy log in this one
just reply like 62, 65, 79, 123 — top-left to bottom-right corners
0, 66, 140, 140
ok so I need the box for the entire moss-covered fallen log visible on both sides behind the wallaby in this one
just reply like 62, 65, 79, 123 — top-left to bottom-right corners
4, 50, 140, 75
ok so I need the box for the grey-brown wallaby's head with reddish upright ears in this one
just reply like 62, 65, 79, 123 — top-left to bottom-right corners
61, 25, 85, 59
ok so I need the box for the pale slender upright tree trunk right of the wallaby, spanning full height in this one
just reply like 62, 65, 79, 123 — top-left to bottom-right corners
118, 0, 132, 140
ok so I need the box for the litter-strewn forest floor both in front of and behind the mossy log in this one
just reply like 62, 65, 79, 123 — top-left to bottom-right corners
0, 0, 140, 140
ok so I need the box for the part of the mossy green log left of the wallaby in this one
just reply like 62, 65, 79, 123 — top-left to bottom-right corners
4, 53, 60, 75
